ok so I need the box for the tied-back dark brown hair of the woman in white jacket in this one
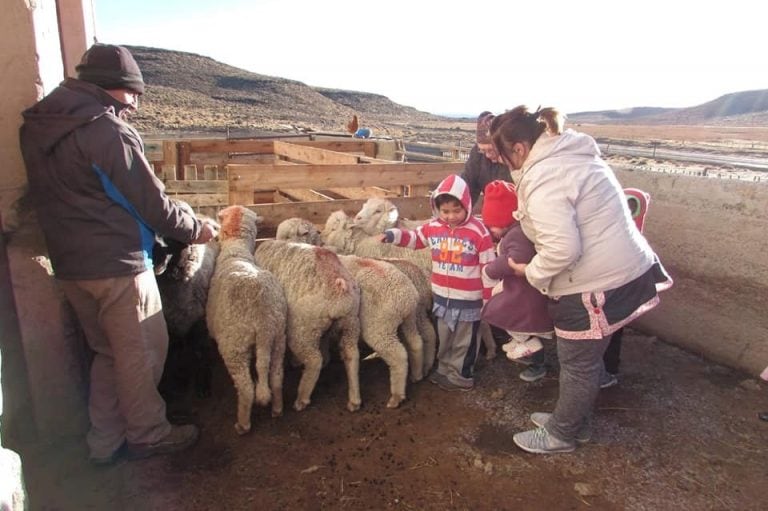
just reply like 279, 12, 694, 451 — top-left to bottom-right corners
490, 105, 565, 165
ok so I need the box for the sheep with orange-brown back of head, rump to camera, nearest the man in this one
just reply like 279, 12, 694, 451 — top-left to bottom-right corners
206, 206, 288, 435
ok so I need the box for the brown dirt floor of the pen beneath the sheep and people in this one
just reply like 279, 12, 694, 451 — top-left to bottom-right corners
15, 328, 768, 511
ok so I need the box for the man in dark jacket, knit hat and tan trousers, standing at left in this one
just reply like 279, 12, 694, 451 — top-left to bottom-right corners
20, 44, 217, 464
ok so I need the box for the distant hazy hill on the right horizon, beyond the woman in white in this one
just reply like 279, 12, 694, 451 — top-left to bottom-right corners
568, 90, 768, 126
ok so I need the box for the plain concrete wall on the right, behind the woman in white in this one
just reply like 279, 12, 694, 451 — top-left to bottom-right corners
615, 169, 768, 376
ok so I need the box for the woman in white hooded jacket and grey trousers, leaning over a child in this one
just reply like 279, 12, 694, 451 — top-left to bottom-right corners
490, 106, 672, 453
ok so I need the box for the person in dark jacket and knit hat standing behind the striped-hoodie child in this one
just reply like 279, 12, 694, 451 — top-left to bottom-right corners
461, 111, 512, 213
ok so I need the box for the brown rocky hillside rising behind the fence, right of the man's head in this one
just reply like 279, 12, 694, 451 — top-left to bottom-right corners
128, 46, 441, 134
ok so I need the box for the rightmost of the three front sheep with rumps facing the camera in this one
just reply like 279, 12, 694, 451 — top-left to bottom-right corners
339, 255, 424, 408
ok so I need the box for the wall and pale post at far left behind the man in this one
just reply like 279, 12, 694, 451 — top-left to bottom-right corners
0, 0, 93, 442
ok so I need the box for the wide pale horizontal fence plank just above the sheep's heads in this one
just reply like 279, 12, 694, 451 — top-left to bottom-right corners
227, 162, 464, 191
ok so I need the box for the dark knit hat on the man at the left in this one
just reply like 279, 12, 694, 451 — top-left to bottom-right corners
75, 43, 144, 94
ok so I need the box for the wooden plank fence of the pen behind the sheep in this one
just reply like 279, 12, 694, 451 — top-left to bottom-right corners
147, 139, 464, 236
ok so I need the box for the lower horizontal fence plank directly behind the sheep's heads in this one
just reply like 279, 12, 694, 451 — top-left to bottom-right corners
246, 197, 432, 228
